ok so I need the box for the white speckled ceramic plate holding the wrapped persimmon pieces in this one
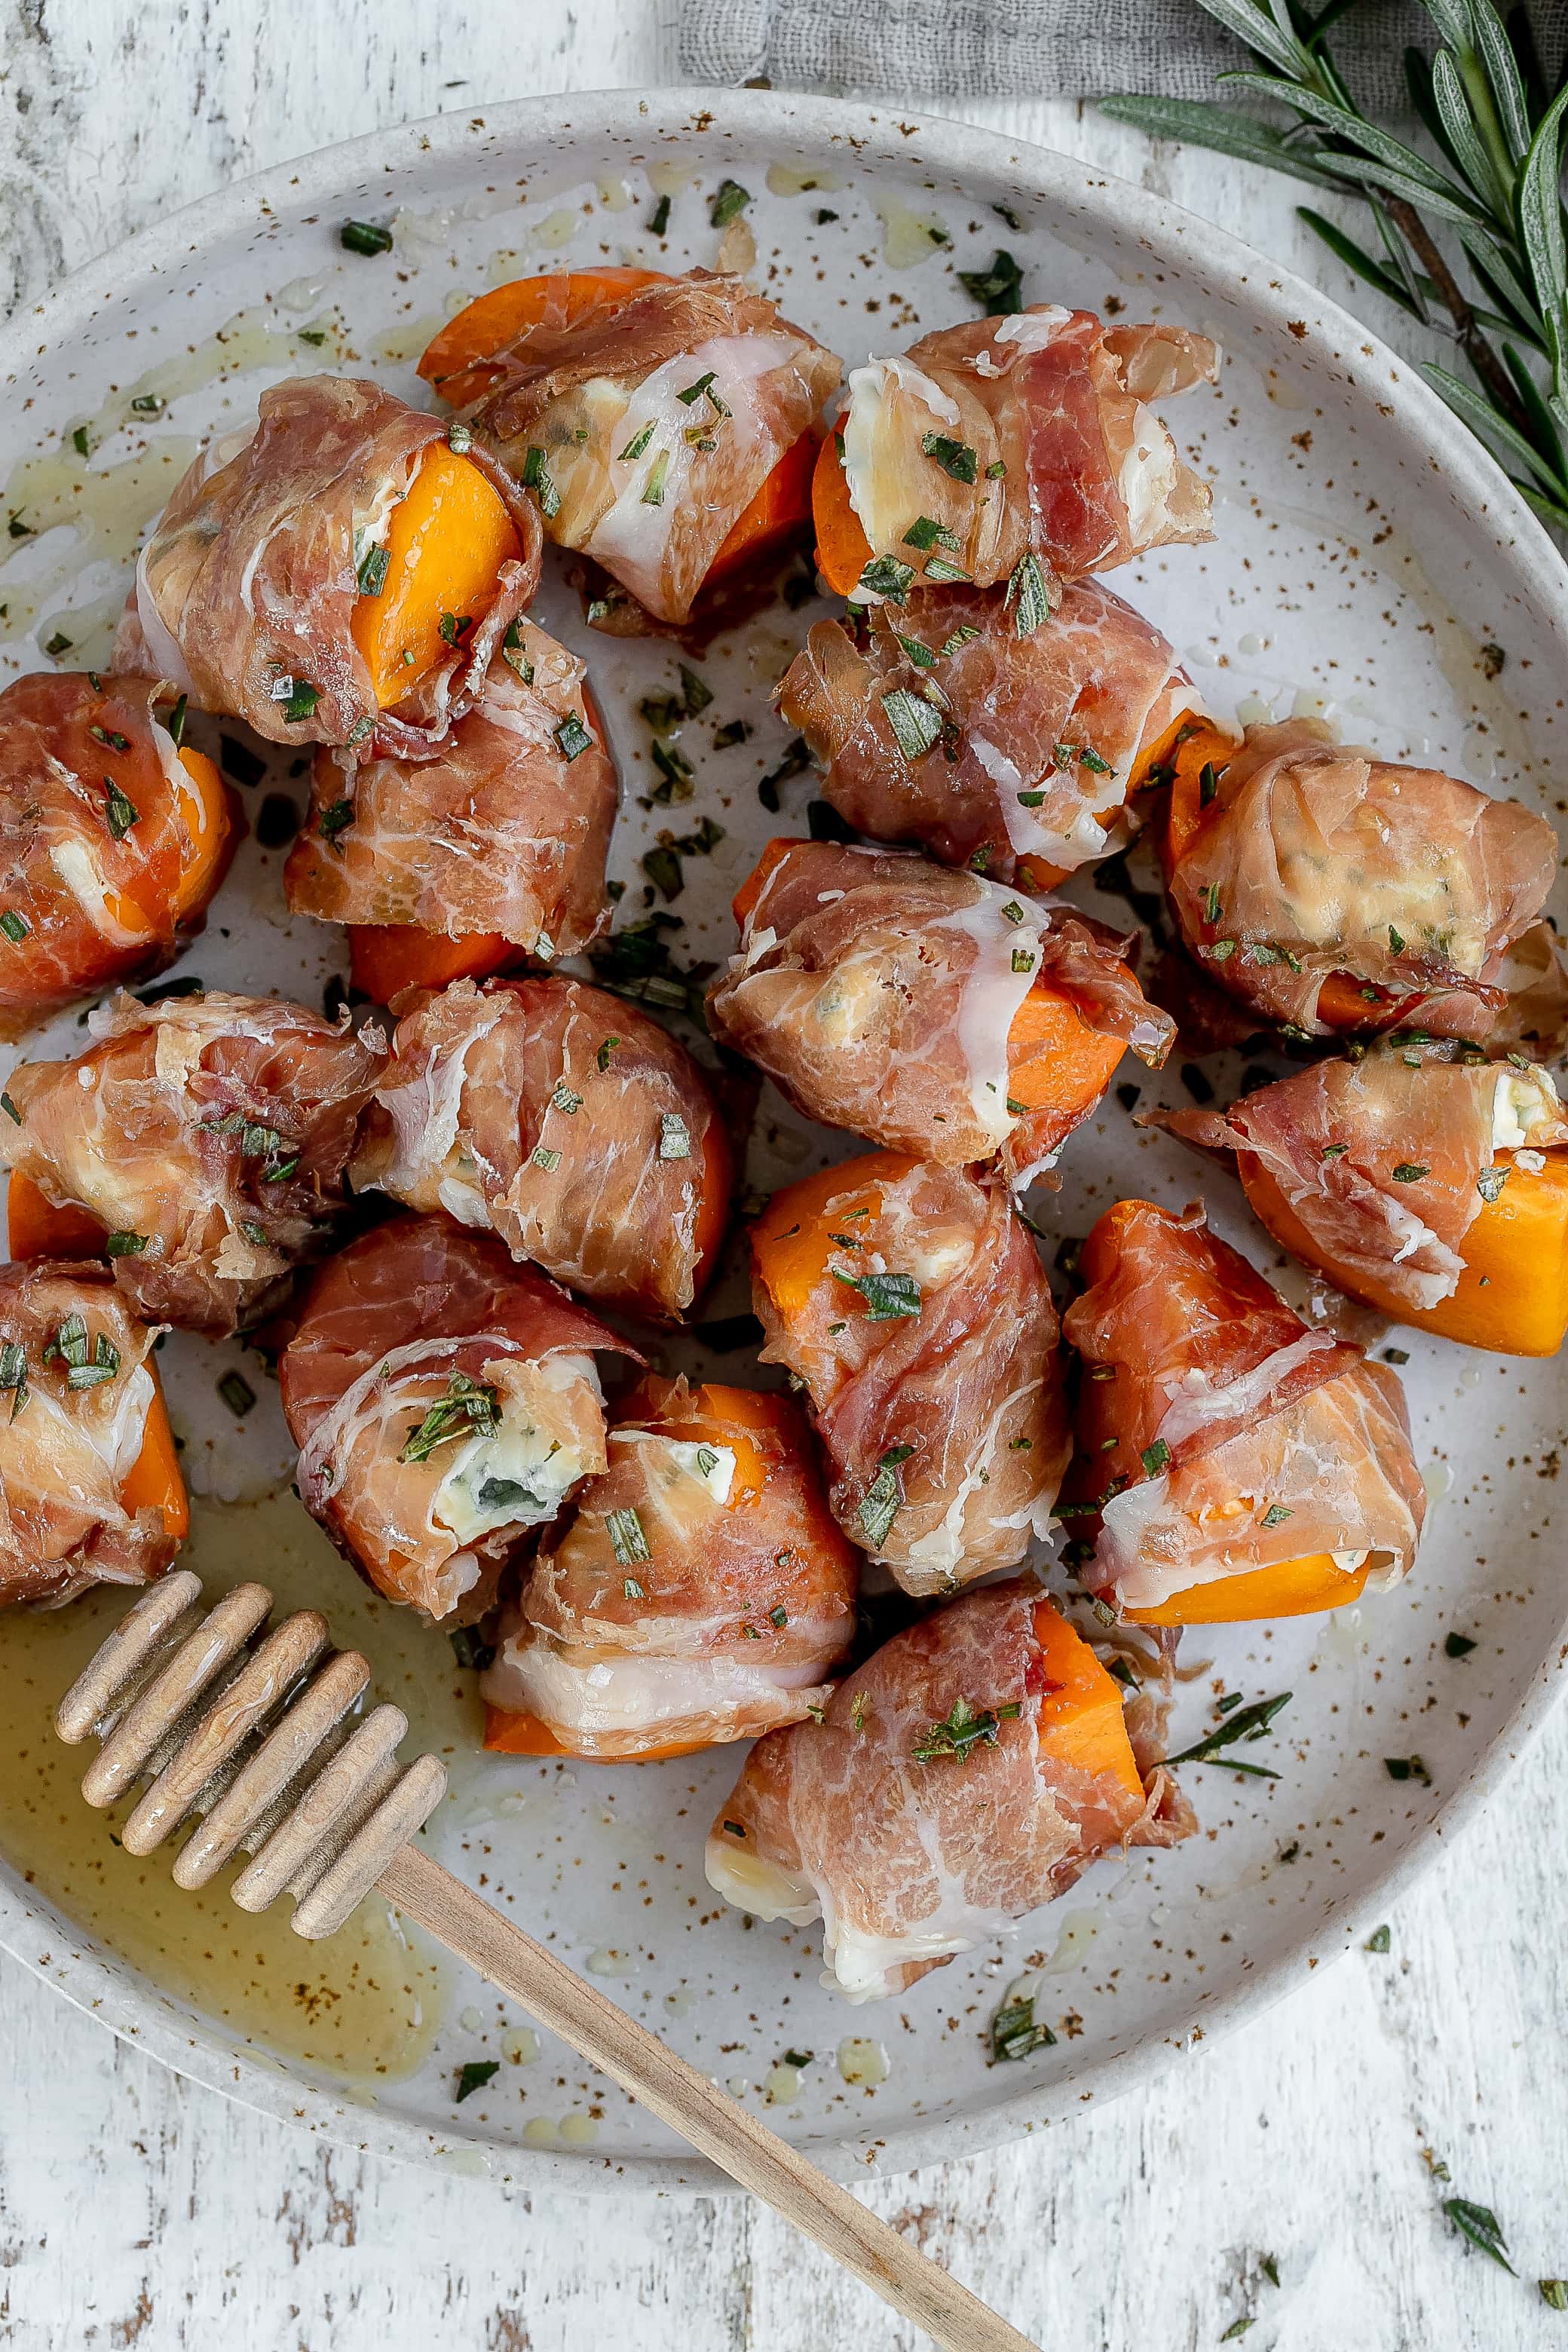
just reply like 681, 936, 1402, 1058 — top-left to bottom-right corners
0, 92, 1568, 2188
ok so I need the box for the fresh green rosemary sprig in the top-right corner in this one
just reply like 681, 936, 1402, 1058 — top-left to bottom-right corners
1103, 0, 1568, 529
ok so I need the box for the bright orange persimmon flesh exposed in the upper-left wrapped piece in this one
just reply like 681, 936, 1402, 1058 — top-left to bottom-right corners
351, 443, 522, 710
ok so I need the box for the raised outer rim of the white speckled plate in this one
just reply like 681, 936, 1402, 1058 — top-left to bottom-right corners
0, 82, 1568, 2197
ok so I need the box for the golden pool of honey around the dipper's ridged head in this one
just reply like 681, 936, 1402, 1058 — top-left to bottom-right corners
0, 1489, 482, 2084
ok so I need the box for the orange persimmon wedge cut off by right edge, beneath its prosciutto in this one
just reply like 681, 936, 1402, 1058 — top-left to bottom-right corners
1236, 1150, 1568, 1355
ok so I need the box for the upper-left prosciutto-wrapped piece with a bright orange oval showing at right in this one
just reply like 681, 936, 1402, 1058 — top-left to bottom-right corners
120, 376, 541, 758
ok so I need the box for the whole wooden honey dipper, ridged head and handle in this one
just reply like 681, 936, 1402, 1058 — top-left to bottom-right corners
54, 1569, 1034, 2352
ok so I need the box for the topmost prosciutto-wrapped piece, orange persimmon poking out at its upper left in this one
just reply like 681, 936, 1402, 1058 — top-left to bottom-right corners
418, 268, 839, 621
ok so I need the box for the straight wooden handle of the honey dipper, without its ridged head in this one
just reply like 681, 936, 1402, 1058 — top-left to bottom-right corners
376, 1846, 1034, 2352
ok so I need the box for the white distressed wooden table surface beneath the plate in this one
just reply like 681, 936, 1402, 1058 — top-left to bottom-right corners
0, 0, 1568, 2352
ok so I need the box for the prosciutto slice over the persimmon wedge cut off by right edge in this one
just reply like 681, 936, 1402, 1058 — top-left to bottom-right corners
1138, 1037, 1568, 1310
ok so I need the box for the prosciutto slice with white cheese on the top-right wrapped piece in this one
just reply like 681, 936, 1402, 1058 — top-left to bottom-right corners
841, 303, 1220, 593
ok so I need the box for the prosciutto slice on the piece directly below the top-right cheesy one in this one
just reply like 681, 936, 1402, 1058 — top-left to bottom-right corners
780, 581, 1196, 882
